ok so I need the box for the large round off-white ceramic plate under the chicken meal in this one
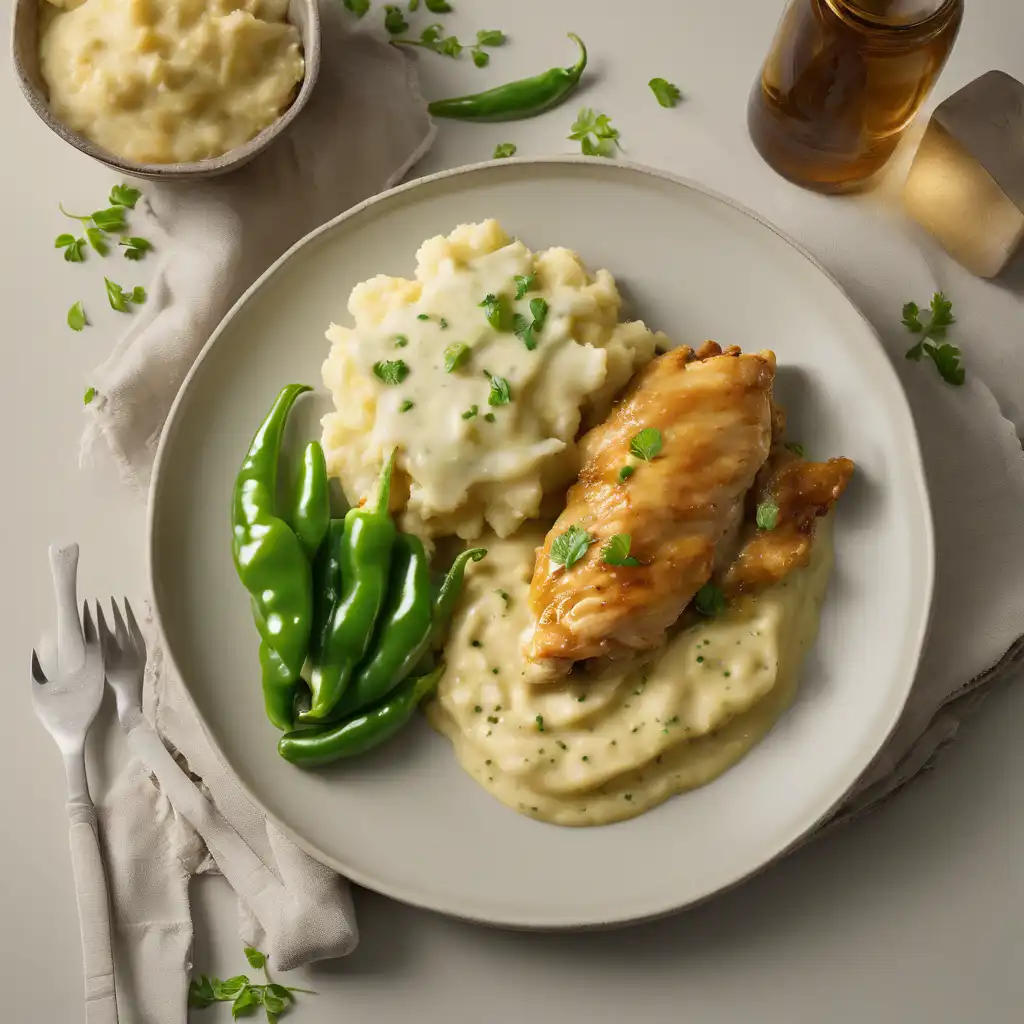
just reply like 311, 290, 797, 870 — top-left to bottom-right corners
150, 159, 933, 928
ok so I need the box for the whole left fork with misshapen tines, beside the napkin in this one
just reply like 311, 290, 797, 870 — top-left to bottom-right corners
32, 544, 118, 1024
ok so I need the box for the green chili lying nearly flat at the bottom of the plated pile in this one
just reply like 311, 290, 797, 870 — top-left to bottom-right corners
278, 666, 444, 768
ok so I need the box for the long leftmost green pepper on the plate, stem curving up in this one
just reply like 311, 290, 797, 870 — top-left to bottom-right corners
231, 384, 312, 729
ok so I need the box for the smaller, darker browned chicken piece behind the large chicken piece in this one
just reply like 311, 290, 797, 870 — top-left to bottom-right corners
723, 447, 853, 597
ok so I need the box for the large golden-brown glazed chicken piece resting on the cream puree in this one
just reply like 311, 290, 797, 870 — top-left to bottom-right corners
526, 342, 775, 674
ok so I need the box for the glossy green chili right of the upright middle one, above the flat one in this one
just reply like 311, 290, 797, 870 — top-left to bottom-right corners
331, 534, 433, 721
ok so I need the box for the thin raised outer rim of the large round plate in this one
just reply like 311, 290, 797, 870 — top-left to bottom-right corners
145, 155, 935, 932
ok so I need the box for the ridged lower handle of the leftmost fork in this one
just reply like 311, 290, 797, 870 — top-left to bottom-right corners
68, 800, 118, 1024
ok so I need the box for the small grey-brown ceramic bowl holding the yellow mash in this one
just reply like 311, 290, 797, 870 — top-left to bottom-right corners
11, 0, 321, 181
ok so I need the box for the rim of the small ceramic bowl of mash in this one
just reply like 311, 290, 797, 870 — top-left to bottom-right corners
10, 0, 322, 180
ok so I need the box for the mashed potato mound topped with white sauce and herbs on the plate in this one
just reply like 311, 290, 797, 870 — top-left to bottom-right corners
323, 220, 659, 539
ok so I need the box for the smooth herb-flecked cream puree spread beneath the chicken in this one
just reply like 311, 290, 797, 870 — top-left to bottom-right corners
428, 521, 833, 825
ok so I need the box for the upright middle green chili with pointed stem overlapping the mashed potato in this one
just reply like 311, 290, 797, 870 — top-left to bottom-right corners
300, 452, 396, 722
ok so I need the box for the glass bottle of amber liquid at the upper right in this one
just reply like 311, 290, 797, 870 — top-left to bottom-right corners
748, 0, 964, 191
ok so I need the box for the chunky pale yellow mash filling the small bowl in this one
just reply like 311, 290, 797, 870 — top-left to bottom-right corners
40, 0, 304, 164
